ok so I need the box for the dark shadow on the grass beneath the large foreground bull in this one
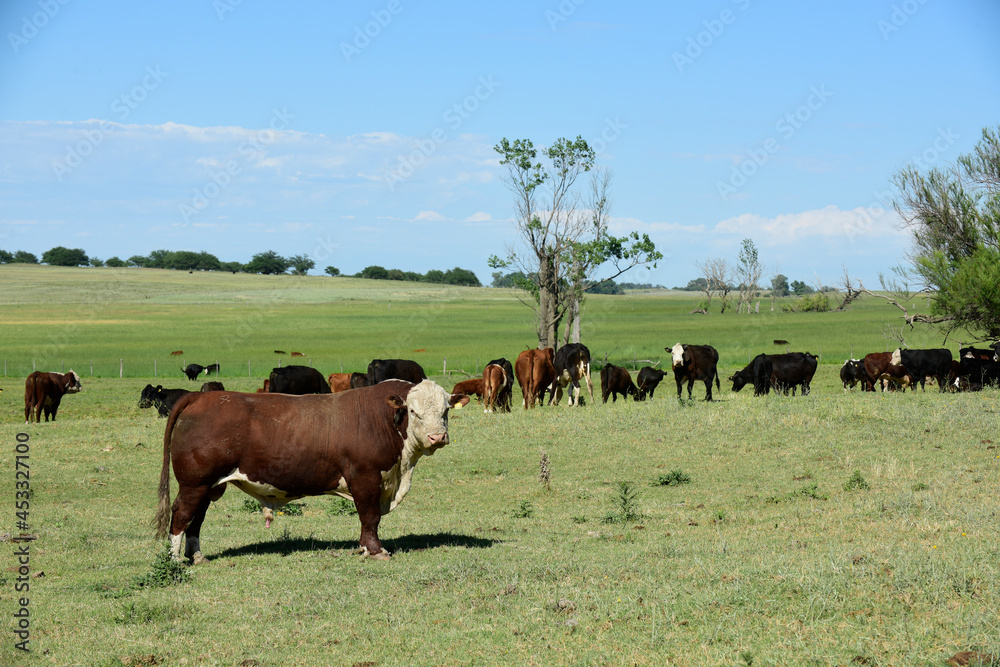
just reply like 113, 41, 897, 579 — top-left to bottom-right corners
209, 531, 500, 558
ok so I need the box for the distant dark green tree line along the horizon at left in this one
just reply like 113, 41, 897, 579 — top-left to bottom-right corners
0, 246, 480, 287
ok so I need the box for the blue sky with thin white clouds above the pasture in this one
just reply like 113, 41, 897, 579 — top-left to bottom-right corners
0, 0, 1000, 287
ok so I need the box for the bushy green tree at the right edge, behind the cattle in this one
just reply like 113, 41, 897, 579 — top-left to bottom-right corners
893, 126, 1000, 339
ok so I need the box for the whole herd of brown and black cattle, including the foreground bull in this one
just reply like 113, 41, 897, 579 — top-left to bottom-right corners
17, 343, 1000, 563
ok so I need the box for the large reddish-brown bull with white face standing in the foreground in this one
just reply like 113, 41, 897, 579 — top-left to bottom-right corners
156, 380, 469, 563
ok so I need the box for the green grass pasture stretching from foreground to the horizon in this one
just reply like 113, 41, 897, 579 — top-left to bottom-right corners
0, 266, 1000, 665
